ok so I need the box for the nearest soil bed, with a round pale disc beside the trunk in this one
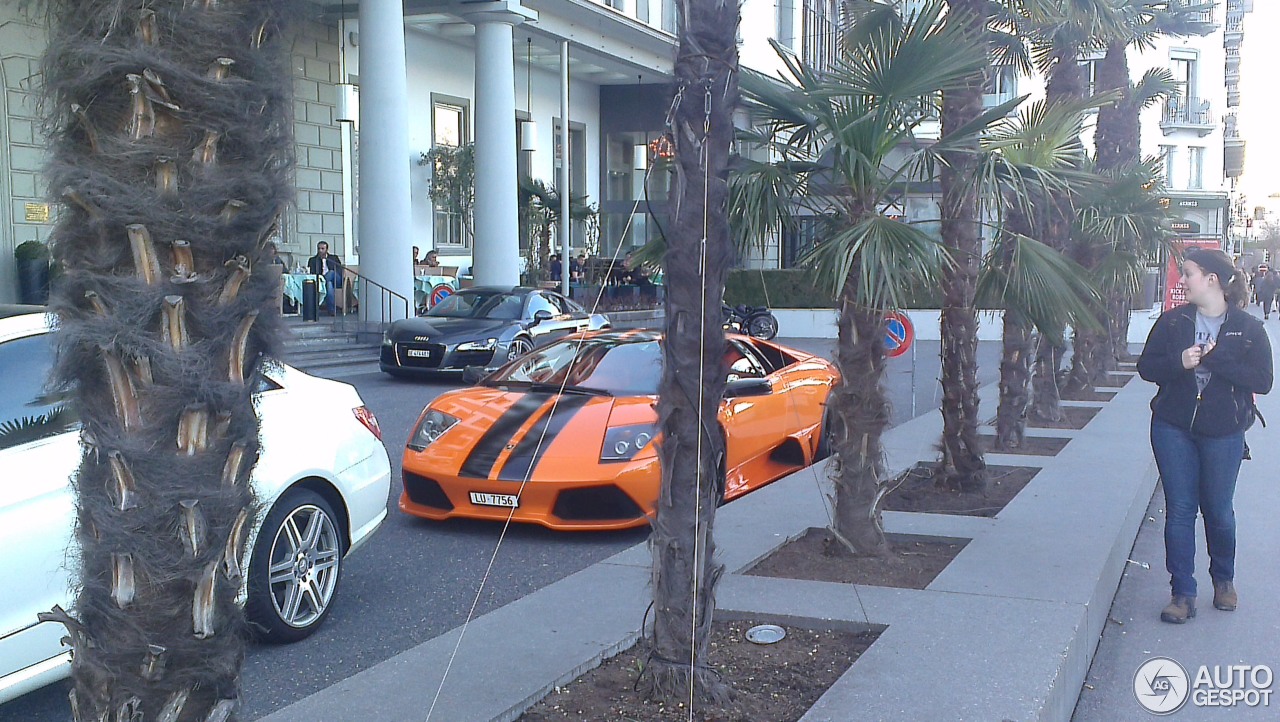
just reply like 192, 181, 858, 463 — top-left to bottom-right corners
518, 620, 879, 722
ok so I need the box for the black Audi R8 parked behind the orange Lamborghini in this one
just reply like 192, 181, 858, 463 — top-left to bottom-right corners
379, 285, 609, 376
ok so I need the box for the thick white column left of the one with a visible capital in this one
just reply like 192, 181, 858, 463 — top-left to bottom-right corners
356, 0, 412, 319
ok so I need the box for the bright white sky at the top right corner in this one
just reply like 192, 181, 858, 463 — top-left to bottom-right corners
1238, 0, 1280, 211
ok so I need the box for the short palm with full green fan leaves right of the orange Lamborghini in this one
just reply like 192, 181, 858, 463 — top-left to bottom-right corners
732, 3, 987, 554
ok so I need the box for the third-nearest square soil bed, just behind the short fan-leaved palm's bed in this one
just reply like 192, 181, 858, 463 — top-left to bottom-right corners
883, 462, 1039, 517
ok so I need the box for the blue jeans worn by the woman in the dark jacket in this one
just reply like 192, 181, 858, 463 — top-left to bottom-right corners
1151, 419, 1244, 597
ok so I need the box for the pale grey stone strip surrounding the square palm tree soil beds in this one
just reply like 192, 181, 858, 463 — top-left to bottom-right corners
266, 355, 1172, 722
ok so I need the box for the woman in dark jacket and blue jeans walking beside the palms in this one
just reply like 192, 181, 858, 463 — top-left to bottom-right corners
1138, 248, 1272, 625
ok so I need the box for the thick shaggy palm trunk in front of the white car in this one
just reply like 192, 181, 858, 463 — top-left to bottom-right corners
44, 0, 292, 722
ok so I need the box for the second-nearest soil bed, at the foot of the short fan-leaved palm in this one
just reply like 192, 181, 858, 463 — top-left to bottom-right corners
744, 527, 969, 589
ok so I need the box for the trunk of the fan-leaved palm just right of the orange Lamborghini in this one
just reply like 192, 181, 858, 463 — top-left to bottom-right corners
827, 279, 890, 556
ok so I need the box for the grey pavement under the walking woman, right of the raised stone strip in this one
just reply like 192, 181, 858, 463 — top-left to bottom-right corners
1073, 321, 1280, 722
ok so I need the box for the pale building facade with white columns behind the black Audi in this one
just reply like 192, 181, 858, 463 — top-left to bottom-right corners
0, 0, 838, 302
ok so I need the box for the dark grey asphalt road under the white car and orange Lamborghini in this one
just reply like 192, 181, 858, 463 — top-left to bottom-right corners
0, 339, 1000, 722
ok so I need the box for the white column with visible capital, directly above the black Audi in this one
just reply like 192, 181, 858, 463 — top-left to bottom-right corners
467, 13, 522, 285
